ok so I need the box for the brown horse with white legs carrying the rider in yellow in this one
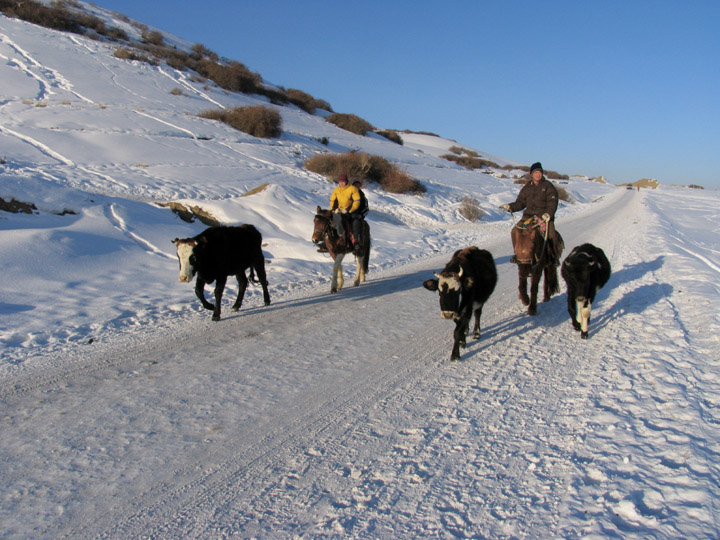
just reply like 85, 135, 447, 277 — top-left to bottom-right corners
312, 206, 370, 292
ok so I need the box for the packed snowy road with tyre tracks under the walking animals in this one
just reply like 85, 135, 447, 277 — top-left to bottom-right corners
0, 191, 720, 538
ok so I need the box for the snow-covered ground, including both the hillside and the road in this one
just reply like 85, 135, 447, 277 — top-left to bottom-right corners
0, 8, 720, 538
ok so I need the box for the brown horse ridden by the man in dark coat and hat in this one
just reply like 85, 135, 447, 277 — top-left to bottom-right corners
512, 218, 563, 315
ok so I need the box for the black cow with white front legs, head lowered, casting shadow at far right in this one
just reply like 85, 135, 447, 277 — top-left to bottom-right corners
560, 244, 610, 339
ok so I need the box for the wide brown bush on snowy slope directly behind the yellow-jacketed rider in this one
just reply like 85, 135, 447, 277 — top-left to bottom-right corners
305, 152, 426, 194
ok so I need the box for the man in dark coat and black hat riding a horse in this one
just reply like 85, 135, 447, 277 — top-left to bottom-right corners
500, 162, 559, 264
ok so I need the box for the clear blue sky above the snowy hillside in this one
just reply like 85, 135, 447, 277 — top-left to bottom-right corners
94, 0, 720, 188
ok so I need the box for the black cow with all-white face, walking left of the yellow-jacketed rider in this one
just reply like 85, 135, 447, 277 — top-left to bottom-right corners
173, 225, 270, 321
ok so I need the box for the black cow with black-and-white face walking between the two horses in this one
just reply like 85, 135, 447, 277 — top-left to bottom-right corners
423, 246, 497, 361
